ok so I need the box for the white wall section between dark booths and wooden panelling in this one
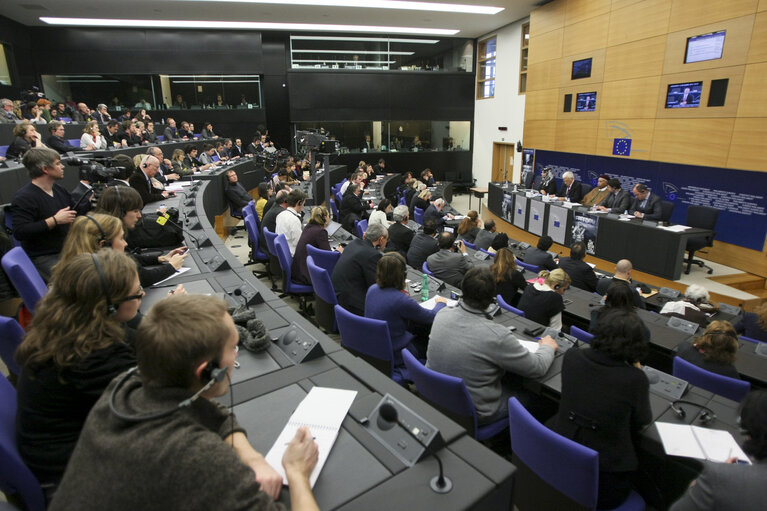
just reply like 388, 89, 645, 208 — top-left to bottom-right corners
472, 18, 529, 186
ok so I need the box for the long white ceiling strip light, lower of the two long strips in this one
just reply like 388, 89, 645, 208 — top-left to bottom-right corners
40, 16, 460, 35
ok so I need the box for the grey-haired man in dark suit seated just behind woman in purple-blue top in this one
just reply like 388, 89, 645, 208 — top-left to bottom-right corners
330, 224, 389, 316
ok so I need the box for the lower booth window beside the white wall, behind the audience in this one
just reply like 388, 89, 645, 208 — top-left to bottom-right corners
295, 121, 471, 154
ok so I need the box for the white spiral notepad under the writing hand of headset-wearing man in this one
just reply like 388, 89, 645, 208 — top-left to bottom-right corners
266, 387, 357, 488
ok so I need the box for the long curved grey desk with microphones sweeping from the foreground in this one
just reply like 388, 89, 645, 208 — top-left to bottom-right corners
142, 173, 515, 511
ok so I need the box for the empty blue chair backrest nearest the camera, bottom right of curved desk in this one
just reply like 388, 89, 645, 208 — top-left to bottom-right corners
509, 397, 599, 509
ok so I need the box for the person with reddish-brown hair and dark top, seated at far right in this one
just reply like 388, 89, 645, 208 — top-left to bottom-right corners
677, 321, 740, 380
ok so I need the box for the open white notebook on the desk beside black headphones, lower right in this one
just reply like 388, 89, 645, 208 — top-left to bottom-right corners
655, 422, 751, 464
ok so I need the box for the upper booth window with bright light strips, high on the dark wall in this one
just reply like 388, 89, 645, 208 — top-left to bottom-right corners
290, 35, 474, 73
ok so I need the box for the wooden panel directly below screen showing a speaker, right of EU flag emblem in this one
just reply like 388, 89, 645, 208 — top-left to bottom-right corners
650, 119, 735, 167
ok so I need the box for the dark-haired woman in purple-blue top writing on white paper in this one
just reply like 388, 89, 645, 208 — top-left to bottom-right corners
365, 252, 447, 367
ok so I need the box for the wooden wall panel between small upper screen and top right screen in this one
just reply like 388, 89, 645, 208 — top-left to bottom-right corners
604, 36, 666, 82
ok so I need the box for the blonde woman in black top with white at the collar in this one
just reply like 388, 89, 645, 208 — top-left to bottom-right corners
517, 268, 570, 330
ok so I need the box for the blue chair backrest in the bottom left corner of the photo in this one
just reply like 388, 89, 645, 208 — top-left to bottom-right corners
0, 374, 45, 511
